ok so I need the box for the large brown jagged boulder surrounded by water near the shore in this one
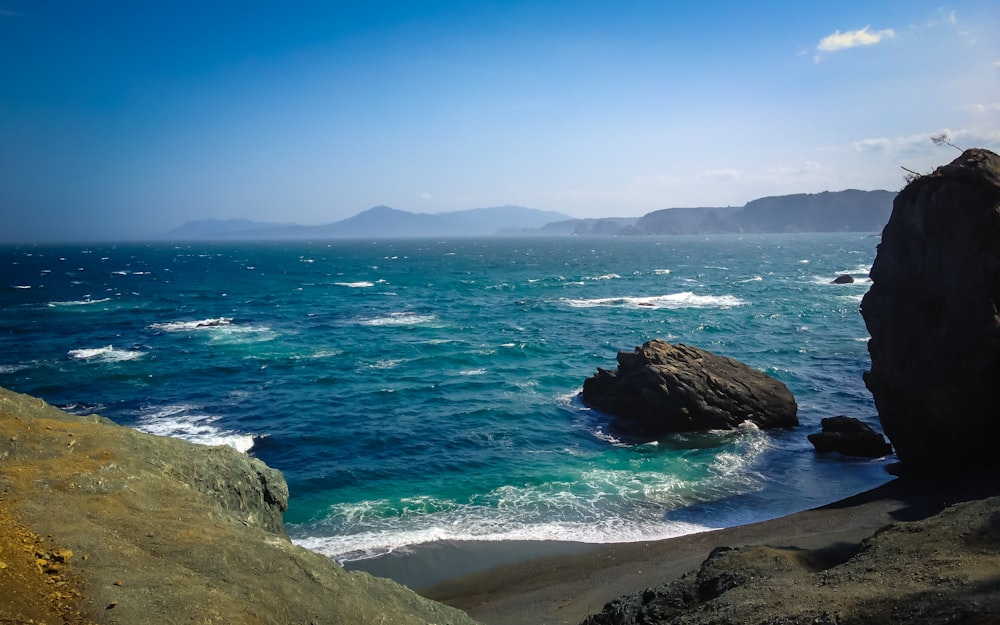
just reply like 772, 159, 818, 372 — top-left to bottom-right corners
583, 340, 799, 440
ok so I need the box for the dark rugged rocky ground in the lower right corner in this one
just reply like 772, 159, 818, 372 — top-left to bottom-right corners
582, 497, 1000, 625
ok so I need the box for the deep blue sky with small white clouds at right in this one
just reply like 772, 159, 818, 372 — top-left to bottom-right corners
0, 0, 1000, 243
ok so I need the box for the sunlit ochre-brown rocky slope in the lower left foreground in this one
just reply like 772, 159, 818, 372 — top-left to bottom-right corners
0, 389, 472, 625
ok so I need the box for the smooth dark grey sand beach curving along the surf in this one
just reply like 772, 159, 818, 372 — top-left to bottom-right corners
353, 479, 995, 625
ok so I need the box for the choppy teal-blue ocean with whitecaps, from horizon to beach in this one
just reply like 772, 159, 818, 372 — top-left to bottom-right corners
0, 233, 894, 562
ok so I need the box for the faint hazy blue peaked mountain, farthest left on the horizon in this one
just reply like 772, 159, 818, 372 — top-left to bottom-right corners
164, 206, 570, 240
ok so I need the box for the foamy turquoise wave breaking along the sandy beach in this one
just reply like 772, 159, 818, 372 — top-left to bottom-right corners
290, 424, 770, 562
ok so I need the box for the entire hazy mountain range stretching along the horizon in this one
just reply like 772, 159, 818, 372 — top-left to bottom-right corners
162, 189, 896, 240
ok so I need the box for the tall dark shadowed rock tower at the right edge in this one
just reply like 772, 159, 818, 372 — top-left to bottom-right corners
861, 149, 1000, 471
